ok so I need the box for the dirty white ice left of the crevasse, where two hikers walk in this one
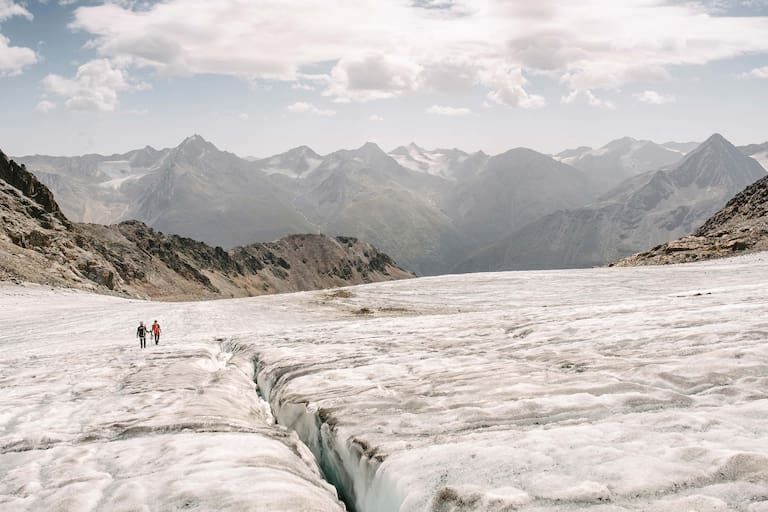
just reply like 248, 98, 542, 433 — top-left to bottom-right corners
0, 286, 344, 512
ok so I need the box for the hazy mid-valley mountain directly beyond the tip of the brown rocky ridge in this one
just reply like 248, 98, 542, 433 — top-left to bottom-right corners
293, 143, 463, 273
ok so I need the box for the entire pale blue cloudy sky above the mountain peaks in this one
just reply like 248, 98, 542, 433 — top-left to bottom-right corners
0, 0, 768, 156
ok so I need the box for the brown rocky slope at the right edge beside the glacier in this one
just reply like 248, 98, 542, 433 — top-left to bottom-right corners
613, 177, 768, 266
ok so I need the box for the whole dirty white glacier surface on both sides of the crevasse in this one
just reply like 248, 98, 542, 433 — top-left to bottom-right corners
0, 255, 768, 512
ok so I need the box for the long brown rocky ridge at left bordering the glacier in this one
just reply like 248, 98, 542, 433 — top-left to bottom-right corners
0, 149, 413, 300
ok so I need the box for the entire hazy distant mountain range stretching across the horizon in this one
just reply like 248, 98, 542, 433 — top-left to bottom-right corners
17, 135, 768, 275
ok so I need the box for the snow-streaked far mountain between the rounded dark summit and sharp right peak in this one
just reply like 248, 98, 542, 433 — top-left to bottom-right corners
554, 137, 688, 194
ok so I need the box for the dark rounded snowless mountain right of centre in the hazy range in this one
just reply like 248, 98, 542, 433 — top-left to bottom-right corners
446, 148, 594, 246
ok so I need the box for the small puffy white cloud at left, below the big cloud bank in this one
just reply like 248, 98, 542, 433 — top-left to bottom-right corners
43, 59, 148, 112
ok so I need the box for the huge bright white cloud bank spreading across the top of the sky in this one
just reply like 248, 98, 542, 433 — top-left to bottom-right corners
73, 0, 768, 108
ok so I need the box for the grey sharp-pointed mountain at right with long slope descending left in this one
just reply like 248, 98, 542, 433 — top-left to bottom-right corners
456, 134, 765, 271
